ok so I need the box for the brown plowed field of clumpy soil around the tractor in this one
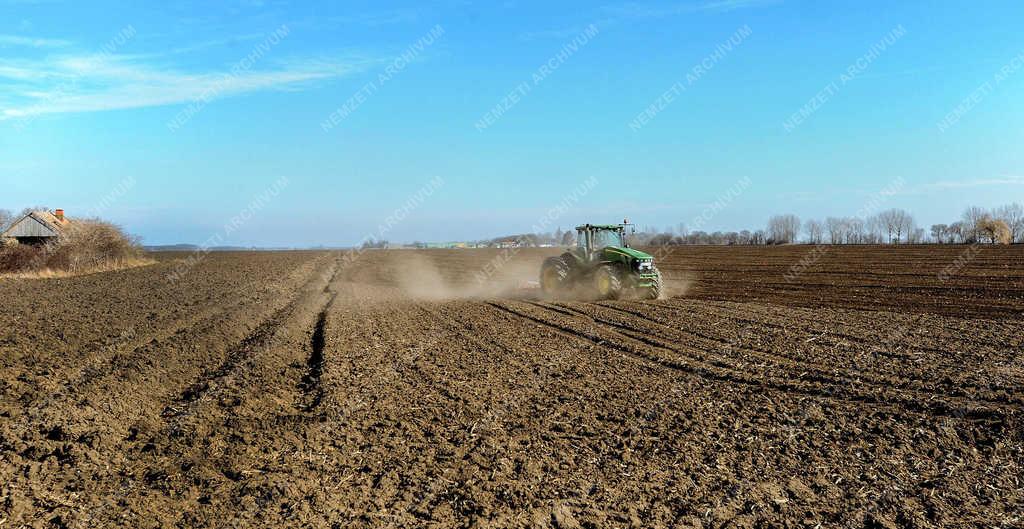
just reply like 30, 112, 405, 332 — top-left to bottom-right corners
0, 247, 1024, 529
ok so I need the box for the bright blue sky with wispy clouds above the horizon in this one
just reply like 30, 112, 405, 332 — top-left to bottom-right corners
0, 0, 1024, 246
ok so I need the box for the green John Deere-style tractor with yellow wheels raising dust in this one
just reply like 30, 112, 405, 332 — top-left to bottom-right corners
541, 224, 662, 300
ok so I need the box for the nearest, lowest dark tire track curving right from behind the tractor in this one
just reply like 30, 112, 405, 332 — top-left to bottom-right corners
487, 302, 1008, 424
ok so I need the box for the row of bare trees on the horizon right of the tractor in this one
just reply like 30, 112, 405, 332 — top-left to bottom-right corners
634, 204, 1024, 246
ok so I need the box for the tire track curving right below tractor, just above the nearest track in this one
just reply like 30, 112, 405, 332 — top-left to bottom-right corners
565, 303, 1024, 406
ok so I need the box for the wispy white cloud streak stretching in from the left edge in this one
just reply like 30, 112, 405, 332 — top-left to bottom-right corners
0, 55, 370, 121
